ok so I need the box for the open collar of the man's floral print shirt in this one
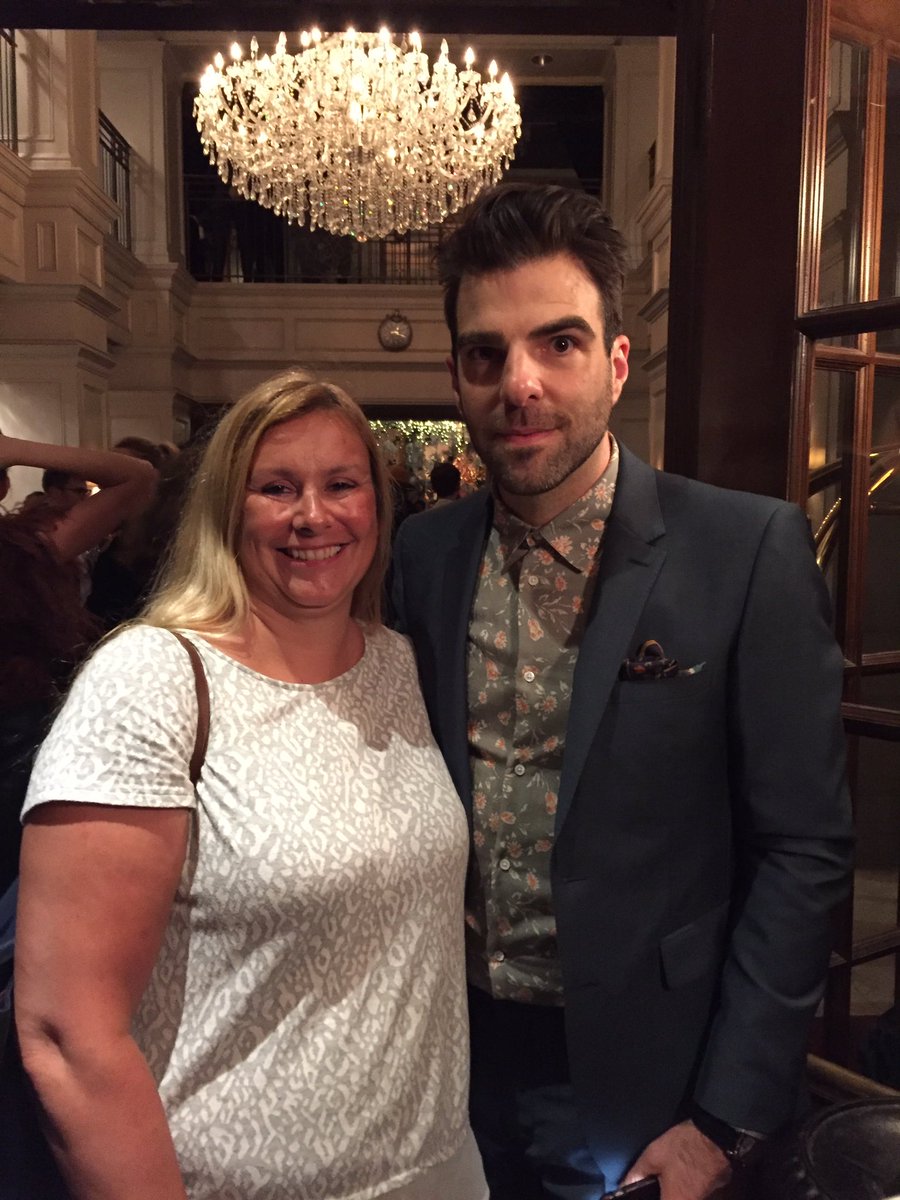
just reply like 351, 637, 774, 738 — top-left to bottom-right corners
493, 434, 619, 572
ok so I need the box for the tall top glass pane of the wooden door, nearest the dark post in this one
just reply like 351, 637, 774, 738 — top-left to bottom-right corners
818, 40, 869, 306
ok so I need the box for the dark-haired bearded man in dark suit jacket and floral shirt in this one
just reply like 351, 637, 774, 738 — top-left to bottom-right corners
392, 184, 852, 1200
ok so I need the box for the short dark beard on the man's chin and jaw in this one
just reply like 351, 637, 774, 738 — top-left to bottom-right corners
463, 385, 612, 496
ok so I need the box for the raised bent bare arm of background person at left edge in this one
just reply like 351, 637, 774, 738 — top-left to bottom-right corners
0, 432, 156, 562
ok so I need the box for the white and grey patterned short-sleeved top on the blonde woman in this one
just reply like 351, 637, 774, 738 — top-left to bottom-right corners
24, 626, 486, 1200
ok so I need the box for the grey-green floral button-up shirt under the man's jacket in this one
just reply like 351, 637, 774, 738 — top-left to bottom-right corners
466, 442, 619, 1004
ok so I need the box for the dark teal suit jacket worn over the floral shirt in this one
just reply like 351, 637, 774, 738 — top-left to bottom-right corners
391, 448, 852, 1180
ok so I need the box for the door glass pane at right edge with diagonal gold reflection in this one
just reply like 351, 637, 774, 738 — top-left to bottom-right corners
863, 372, 900, 654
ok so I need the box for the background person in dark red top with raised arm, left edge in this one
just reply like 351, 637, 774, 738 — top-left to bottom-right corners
0, 433, 154, 892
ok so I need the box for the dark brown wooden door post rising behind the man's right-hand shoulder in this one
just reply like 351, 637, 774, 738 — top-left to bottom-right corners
665, 0, 806, 497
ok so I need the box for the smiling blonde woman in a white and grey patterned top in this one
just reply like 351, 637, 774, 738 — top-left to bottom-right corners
17, 372, 486, 1200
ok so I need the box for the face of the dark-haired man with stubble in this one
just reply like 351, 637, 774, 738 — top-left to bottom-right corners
448, 254, 629, 526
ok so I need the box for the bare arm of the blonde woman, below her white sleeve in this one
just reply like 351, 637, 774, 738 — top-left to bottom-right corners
16, 803, 191, 1200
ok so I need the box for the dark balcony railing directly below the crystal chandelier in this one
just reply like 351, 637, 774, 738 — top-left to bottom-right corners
185, 175, 440, 284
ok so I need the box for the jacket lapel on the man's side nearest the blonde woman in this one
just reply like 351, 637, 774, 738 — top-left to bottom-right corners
434, 490, 492, 809
